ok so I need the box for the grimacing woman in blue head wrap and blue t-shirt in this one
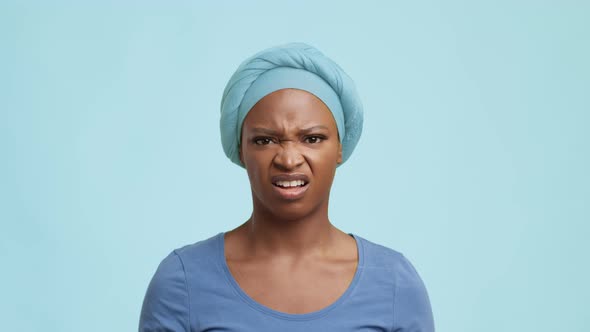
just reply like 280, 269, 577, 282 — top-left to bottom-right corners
139, 43, 434, 332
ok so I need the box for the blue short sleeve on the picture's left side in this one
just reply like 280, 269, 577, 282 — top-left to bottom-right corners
139, 252, 190, 332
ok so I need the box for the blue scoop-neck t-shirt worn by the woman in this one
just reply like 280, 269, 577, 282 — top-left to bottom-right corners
139, 233, 434, 332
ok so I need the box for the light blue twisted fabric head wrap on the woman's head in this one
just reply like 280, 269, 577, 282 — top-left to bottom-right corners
220, 43, 363, 167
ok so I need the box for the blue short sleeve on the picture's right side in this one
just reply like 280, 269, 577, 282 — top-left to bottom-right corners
393, 255, 434, 332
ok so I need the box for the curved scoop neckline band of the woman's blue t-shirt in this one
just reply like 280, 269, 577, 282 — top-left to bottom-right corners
215, 232, 364, 321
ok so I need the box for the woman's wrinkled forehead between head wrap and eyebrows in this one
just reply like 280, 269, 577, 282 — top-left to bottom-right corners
243, 89, 337, 130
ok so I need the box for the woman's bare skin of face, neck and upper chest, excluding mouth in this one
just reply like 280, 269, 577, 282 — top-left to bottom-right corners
225, 89, 358, 314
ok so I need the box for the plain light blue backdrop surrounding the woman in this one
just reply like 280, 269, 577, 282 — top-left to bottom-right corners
0, 0, 590, 332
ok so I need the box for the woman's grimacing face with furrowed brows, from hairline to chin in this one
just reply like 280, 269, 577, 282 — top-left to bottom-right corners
240, 89, 342, 220
